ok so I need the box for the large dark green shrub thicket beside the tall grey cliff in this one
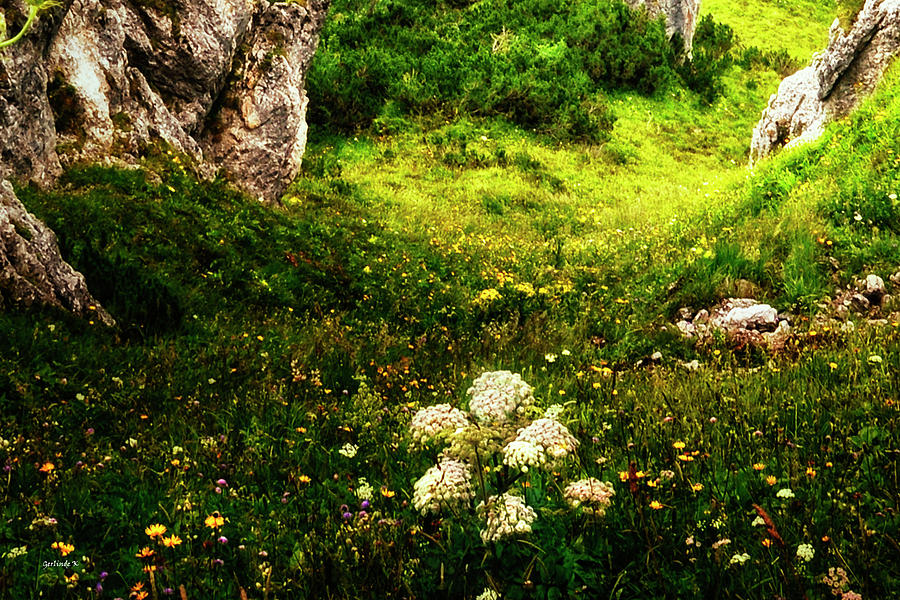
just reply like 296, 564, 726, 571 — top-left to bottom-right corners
308, 0, 700, 142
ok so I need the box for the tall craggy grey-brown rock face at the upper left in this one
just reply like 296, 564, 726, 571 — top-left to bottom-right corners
0, 0, 327, 201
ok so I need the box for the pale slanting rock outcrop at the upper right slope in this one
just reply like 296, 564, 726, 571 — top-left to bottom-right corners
750, 0, 900, 164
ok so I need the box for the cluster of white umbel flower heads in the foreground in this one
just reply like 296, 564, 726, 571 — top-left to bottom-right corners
410, 371, 615, 543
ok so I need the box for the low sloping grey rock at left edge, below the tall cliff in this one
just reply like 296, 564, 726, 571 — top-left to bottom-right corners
0, 181, 115, 325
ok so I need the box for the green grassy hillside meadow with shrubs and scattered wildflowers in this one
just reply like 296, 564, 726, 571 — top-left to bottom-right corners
0, 0, 900, 600
